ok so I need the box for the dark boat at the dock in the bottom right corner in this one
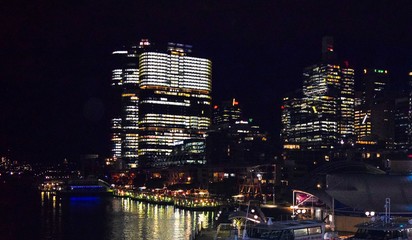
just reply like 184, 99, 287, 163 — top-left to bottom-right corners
350, 218, 412, 240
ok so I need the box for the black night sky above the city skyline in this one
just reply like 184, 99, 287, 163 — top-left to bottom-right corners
0, 0, 412, 161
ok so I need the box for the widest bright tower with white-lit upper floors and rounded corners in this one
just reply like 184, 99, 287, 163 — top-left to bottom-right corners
138, 43, 212, 166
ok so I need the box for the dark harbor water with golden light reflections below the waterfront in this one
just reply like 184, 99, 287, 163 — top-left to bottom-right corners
0, 183, 215, 240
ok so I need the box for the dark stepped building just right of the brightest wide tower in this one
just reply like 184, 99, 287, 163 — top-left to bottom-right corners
206, 99, 273, 166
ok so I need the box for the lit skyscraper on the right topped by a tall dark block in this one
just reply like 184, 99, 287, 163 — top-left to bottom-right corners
282, 37, 355, 150
